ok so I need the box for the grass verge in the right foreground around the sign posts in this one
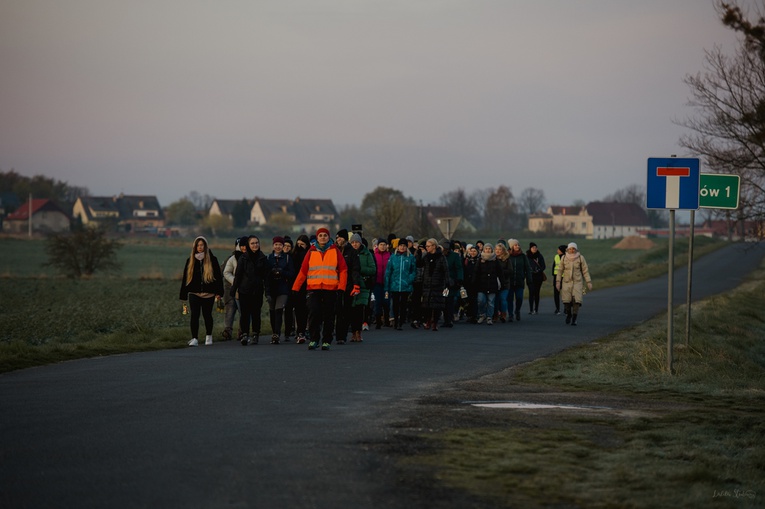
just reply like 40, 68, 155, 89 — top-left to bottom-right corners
394, 258, 765, 509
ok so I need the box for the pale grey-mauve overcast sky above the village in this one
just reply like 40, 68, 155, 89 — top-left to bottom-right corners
0, 0, 755, 206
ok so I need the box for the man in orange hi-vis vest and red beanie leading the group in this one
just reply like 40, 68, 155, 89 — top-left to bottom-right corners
292, 228, 356, 350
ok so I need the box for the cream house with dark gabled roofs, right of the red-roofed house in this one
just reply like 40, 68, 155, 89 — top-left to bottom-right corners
72, 194, 165, 233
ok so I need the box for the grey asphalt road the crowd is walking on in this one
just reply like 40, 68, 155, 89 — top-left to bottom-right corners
0, 244, 765, 509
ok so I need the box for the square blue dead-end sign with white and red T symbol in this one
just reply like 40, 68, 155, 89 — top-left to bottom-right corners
646, 157, 700, 210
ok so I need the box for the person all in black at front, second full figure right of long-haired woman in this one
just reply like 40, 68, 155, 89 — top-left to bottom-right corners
231, 235, 268, 346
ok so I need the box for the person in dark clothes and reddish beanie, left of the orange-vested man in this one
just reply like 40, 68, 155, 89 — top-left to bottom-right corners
266, 237, 295, 345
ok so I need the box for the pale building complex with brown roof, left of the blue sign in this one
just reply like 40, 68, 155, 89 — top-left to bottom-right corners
529, 202, 651, 239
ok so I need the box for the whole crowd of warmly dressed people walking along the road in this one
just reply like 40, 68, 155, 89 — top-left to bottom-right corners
180, 228, 592, 350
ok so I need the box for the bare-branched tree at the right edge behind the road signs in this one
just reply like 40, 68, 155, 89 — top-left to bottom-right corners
675, 2, 765, 226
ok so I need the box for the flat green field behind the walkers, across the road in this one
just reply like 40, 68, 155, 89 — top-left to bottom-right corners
0, 238, 722, 372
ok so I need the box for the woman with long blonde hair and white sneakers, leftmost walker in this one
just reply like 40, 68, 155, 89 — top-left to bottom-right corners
180, 237, 223, 346
